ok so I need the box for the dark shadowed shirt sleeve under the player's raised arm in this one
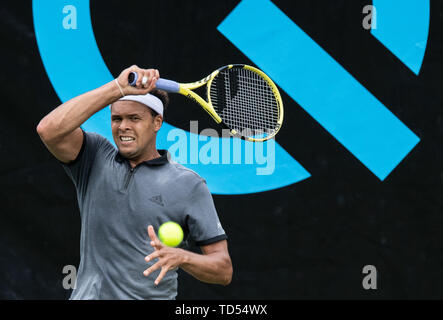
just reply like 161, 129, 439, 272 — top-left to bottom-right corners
59, 130, 105, 200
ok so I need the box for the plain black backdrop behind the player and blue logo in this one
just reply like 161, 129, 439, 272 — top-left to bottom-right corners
0, 0, 443, 299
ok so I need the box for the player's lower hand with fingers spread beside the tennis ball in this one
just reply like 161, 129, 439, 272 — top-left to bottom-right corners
143, 225, 185, 285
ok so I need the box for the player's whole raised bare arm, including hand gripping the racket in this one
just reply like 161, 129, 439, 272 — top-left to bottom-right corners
37, 66, 159, 163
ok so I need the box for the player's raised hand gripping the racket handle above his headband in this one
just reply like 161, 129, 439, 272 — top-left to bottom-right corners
117, 65, 160, 95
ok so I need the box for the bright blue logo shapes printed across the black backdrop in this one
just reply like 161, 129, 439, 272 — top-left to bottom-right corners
33, 0, 429, 194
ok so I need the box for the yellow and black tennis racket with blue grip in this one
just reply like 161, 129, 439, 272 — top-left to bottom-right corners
128, 64, 283, 141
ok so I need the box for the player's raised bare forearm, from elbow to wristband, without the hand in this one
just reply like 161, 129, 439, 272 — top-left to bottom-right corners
39, 81, 121, 140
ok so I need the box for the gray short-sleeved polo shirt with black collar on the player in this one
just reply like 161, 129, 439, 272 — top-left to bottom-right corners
63, 132, 227, 299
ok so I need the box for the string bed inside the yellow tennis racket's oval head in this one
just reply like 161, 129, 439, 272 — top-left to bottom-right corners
210, 67, 279, 137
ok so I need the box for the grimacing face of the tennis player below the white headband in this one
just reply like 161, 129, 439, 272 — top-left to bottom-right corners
111, 101, 162, 160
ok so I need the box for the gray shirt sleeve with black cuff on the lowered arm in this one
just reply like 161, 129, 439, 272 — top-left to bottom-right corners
185, 179, 228, 246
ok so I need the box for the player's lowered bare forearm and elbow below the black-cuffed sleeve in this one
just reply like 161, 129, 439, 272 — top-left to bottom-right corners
180, 250, 232, 285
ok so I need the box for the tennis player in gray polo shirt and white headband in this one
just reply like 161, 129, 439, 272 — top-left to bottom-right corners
37, 66, 232, 299
